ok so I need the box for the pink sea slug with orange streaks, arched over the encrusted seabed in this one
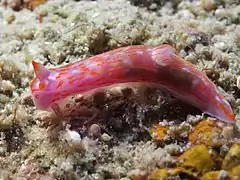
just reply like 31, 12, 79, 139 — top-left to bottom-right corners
31, 45, 235, 123
